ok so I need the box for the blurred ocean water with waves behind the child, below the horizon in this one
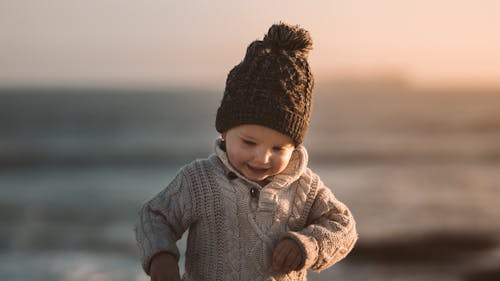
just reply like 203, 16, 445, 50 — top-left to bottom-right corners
0, 85, 500, 281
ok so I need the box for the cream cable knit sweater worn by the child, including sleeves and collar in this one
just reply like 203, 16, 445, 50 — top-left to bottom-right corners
136, 139, 357, 280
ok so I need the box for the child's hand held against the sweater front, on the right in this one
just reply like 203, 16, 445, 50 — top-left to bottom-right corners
273, 238, 304, 273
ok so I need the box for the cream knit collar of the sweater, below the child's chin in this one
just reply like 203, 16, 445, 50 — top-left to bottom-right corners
215, 138, 308, 188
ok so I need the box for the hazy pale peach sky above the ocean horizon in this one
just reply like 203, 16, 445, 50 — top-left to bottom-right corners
0, 0, 500, 88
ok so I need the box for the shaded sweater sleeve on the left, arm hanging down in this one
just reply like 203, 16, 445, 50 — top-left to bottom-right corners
135, 167, 193, 274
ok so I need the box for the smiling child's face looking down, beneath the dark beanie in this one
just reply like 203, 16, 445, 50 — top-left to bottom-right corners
222, 125, 295, 182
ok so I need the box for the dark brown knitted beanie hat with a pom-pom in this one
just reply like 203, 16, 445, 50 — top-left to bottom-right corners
215, 23, 314, 145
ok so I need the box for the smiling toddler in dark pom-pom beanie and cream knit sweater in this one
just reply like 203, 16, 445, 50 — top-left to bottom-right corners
136, 23, 357, 281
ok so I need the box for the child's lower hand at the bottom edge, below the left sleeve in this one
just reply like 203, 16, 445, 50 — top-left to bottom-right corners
149, 253, 181, 281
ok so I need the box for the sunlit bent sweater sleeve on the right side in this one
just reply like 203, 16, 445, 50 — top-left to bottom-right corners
284, 176, 358, 272
